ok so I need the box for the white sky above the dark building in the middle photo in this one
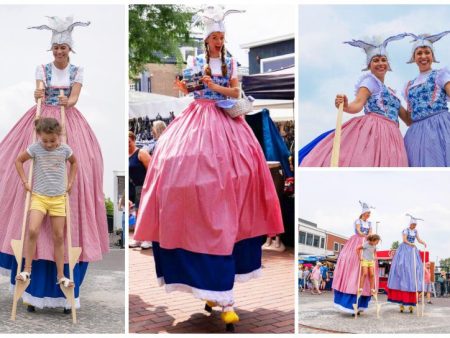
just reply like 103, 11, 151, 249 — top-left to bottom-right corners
190, 3, 296, 67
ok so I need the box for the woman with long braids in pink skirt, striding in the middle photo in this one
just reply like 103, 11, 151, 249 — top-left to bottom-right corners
134, 5, 283, 331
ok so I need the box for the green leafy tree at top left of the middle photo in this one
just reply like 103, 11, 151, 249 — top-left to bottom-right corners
129, 5, 194, 76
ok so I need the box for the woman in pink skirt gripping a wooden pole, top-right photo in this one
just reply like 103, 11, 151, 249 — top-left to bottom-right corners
301, 33, 409, 167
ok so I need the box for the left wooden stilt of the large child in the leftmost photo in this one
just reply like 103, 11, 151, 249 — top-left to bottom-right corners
11, 81, 44, 320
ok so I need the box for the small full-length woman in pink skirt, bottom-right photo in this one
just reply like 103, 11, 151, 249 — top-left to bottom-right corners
332, 201, 378, 314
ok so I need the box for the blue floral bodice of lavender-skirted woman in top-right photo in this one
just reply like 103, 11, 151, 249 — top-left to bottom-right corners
405, 70, 448, 121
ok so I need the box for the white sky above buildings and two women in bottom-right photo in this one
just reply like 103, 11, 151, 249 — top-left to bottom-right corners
296, 169, 450, 260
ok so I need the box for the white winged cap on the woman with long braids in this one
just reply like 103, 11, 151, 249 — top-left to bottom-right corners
193, 5, 245, 40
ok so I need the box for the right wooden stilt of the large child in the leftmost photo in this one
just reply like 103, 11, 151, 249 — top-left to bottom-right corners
59, 89, 81, 324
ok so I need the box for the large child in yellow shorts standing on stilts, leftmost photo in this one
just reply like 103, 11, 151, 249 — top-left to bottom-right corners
16, 118, 77, 287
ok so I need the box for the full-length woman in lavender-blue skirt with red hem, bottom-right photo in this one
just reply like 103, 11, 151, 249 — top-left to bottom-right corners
388, 214, 427, 313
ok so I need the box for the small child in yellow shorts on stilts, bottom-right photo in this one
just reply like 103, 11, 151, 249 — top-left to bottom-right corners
356, 234, 380, 296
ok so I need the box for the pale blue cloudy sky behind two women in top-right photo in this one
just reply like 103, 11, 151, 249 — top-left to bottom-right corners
297, 5, 450, 147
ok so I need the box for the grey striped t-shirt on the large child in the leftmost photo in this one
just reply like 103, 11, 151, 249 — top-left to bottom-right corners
27, 142, 73, 196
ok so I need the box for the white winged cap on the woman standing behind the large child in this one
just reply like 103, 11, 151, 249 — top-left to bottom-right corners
28, 16, 91, 51
